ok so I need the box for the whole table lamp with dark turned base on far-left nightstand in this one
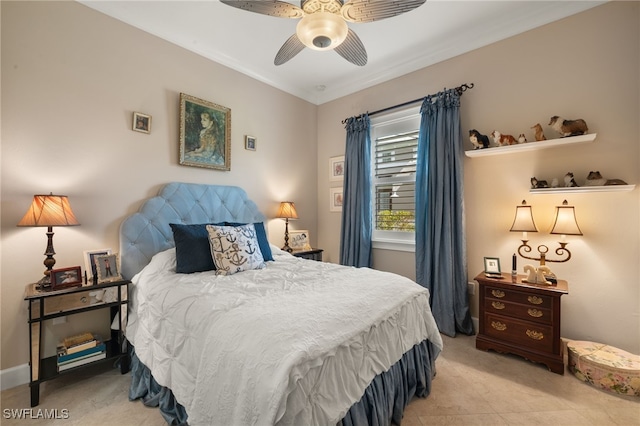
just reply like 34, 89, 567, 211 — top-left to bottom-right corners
18, 194, 80, 288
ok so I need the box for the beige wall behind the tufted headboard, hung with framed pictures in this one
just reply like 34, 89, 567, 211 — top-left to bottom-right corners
0, 2, 317, 369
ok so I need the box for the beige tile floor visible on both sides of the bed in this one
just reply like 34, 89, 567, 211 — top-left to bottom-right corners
0, 336, 640, 426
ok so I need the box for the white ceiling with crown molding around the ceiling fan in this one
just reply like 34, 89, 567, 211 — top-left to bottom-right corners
77, 0, 605, 105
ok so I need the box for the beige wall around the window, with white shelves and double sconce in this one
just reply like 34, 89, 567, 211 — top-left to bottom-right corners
318, 2, 640, 353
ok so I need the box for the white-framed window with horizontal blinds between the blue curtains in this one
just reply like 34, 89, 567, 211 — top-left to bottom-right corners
371, 106, 420, 251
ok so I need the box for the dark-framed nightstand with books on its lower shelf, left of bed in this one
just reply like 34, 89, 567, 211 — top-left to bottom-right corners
24, 281, 131, 407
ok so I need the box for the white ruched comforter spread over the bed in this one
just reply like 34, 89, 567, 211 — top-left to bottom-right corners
126, 247, 442, 426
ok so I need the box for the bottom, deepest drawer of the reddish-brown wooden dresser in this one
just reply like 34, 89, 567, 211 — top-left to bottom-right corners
484, 313, 554, 353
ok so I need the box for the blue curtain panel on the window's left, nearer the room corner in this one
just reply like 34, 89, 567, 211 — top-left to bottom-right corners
340, 114, 371, 267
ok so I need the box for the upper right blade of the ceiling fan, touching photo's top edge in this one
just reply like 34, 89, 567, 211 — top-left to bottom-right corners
340, 0, 427, 23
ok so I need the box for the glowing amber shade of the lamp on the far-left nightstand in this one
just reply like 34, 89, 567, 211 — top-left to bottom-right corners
18, 194, 80, 226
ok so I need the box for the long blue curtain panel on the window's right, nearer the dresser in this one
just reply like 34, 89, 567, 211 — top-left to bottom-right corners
416, 89, 474, 336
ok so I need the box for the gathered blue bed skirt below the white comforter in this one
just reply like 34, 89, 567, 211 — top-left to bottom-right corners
129, 340, 440, 426
